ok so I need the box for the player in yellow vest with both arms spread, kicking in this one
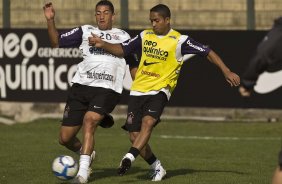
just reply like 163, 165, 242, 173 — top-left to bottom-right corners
89, 4, 240, 181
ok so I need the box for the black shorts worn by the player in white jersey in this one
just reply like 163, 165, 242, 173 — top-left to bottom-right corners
62, 83, 121, 126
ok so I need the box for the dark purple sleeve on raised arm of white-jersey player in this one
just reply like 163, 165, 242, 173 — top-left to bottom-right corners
59, 27, 83, 48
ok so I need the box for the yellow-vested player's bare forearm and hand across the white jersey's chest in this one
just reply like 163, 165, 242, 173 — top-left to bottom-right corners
88, 33, 124, 57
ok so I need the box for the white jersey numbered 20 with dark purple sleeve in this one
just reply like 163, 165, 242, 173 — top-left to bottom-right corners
60, 25, 130, 93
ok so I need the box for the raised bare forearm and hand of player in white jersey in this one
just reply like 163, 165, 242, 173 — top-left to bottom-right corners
43, 2, 59, 47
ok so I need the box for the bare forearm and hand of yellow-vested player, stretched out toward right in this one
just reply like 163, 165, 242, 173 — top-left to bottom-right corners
207, 50, 240, 87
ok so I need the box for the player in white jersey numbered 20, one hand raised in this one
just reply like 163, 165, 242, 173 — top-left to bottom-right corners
43, 0, 138, 183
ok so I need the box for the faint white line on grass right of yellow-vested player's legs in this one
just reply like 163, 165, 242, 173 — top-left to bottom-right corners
160, 135, 282, 141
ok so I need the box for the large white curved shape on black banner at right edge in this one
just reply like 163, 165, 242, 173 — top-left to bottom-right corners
254, 70, 282, 94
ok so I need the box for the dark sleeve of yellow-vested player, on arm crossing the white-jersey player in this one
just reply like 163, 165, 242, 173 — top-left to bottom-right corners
121, 35, 142, 56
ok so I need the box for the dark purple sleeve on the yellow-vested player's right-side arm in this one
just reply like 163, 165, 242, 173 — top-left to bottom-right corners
181, 36, 210, 56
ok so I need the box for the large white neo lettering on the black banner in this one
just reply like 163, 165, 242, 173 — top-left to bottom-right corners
0, 33, 38, 58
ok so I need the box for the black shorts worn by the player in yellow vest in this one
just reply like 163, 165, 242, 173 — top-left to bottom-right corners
122, 92, 168, 132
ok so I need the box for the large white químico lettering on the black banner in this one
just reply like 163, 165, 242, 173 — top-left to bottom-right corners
0, 58, 76, 98
